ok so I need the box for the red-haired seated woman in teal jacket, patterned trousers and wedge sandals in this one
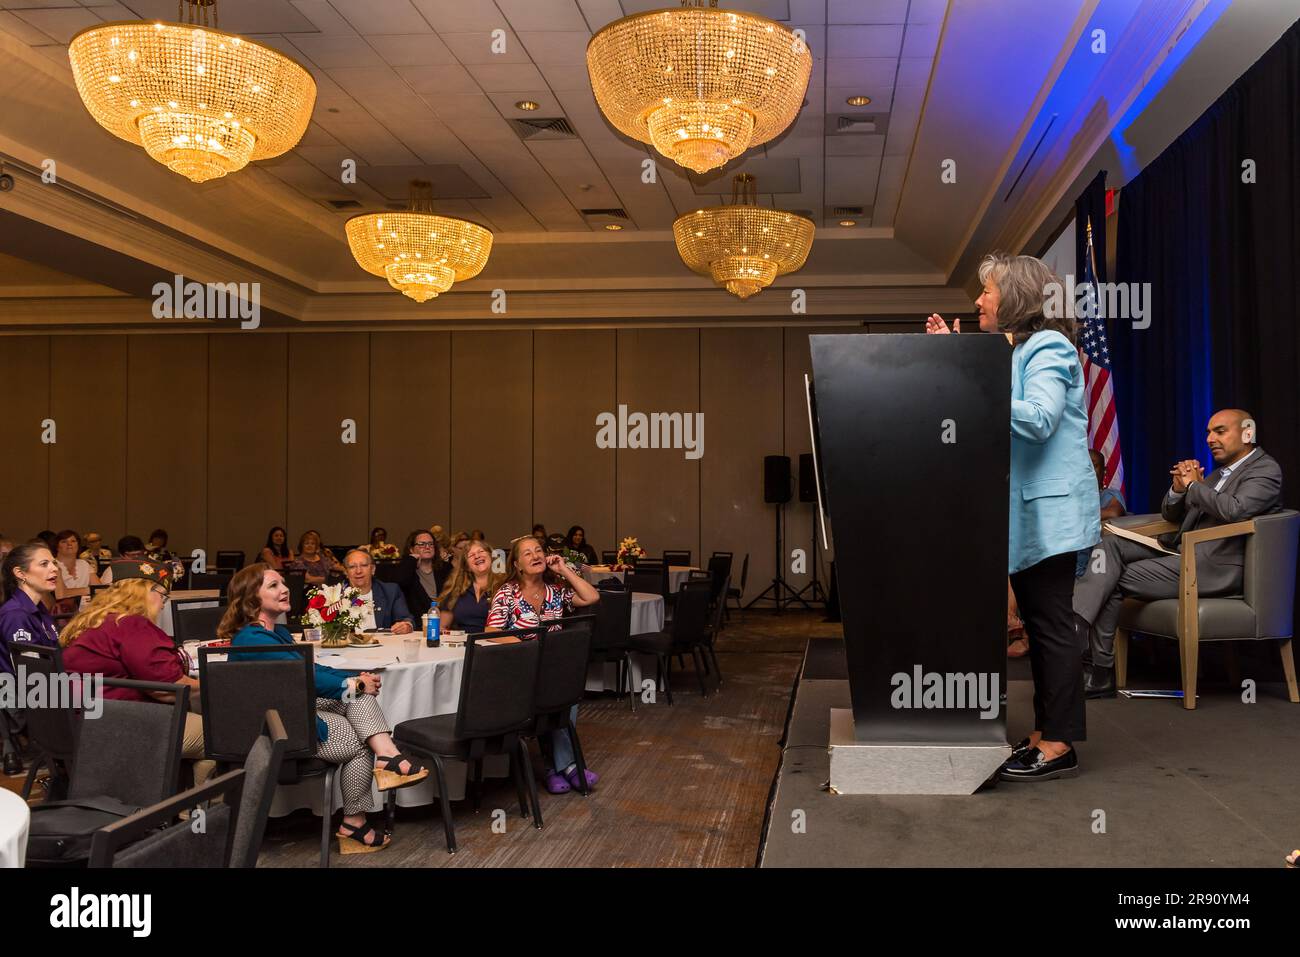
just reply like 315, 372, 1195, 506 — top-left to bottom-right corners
217, 564, 429, 850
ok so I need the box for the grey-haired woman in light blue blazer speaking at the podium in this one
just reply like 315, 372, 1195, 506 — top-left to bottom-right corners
926, 254, 1101, 781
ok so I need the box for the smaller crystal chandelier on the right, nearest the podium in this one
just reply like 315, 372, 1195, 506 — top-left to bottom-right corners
672, 173, 816, 299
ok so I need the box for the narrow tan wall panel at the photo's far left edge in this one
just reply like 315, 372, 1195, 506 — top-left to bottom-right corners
0, 335, 50, 544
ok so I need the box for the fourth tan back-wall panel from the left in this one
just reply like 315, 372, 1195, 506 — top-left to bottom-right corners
208, 333, 293, 562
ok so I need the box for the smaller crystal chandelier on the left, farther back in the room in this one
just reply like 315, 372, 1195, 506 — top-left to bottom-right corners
345, 179, 491, 303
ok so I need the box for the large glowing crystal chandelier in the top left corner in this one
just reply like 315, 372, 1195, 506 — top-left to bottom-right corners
68, 0, 316, 183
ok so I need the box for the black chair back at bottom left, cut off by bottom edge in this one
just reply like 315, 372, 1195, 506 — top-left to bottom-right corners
90, 770, 246, 867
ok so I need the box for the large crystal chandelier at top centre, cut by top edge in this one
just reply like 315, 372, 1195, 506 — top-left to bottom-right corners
586, 0, 813, 173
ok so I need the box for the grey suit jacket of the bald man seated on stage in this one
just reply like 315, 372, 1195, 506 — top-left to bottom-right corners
1160, 447, 1282, 593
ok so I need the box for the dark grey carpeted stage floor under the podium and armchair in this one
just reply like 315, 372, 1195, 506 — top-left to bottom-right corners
759, 640, 1300, 867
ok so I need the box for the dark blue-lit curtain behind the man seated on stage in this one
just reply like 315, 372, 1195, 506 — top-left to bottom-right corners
1109, 22, 1300, 512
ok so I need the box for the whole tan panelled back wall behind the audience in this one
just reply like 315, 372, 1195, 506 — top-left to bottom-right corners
0, 325, 902, 596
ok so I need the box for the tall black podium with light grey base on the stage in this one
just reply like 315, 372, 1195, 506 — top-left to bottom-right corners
810, 334, 1011, 794
